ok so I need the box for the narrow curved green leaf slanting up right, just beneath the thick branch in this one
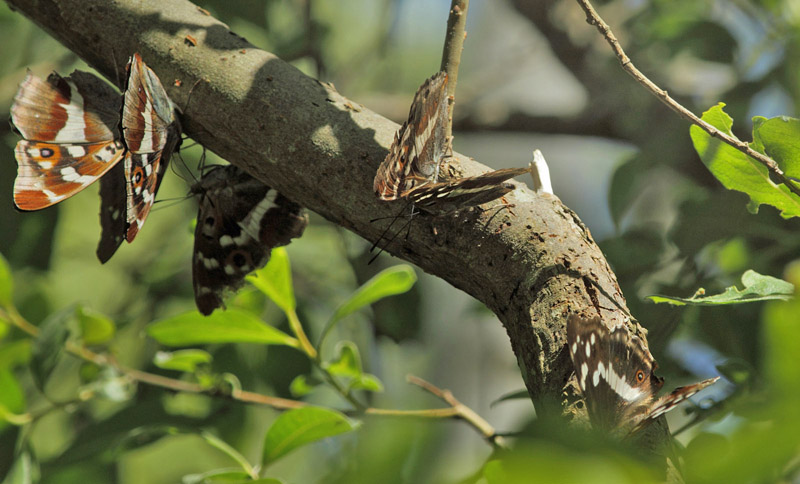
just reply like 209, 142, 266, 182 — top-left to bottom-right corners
317, 265, 417, 348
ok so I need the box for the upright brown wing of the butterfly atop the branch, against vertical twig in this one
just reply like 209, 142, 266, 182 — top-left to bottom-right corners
373, 71, 449, 200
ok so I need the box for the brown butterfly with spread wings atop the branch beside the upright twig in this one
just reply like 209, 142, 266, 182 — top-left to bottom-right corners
373, 71, 530, 213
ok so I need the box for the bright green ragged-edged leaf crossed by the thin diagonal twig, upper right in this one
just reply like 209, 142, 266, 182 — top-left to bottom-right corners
690, 103, 800, 218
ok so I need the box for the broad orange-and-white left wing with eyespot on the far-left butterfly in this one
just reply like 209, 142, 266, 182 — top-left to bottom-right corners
11, 71, 124, 210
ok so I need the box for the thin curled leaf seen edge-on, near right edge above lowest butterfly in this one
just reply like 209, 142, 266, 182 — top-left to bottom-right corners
647, 270, 794, 306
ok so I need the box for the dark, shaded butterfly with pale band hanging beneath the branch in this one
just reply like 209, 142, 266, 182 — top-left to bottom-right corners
192, 165, 308, 315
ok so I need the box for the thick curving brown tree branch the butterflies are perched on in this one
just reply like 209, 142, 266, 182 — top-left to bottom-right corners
7, 0, 640, 432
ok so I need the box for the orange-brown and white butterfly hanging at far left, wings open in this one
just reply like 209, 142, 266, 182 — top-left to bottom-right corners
11, 54, 180, 262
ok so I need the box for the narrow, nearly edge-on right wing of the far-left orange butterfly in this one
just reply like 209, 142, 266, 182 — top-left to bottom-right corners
122, 53, 180, 242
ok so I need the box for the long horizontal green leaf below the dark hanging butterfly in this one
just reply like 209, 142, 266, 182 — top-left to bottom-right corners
147, 309, 299, 348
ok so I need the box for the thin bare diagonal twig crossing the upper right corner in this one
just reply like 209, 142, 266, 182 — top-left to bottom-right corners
577, 0, 800, 196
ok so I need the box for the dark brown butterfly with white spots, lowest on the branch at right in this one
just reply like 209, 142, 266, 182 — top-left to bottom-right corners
567, 315, 719, 436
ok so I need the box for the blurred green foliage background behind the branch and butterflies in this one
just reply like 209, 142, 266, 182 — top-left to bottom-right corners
0, 0, 800, 484
